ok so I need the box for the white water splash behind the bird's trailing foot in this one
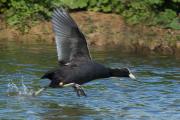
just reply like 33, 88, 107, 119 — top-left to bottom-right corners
7, 76, 34, 96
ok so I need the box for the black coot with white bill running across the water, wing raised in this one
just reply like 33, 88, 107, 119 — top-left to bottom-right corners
39, 8, 135, 96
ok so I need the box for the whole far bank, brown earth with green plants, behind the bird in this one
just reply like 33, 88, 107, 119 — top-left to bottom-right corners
0, 0, 180, 55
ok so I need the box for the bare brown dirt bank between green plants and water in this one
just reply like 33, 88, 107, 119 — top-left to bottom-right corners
0, 12, 180, 54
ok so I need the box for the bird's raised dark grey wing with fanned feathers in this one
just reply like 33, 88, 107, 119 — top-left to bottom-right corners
52, 8, 91, 64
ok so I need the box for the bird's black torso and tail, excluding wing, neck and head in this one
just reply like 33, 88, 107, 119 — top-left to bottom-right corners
43, 61, 110, 87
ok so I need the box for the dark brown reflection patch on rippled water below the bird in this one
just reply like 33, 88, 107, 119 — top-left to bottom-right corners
40, 102, 100, 120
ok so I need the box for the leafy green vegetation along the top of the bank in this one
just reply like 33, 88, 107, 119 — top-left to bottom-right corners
0, 0, 180, 30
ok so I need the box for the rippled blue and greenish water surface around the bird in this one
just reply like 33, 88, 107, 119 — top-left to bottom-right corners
0, 40, 180, 120
